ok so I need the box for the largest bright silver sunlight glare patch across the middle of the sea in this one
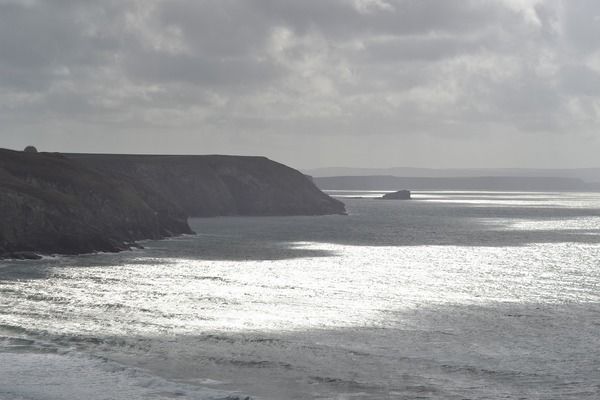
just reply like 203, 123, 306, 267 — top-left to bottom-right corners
0, 243, 600, 335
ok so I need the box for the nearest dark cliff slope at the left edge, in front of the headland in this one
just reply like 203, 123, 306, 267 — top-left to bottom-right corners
0, 149, 191, 257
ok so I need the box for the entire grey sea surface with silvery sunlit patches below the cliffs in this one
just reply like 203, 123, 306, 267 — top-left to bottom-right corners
0, 192, 600, 400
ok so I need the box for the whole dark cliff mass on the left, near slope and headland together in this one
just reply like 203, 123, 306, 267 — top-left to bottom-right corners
0, 149, 345, 258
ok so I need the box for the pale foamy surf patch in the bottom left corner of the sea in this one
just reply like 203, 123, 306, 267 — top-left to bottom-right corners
0, 352, 246, 400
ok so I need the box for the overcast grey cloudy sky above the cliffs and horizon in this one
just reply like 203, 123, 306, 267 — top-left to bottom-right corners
0, 0, 600, 168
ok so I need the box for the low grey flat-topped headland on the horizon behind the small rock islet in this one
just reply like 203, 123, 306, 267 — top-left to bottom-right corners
313, 176, 600, 192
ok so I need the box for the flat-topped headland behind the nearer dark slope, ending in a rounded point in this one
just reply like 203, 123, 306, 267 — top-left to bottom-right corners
68, 154, 345, 217
